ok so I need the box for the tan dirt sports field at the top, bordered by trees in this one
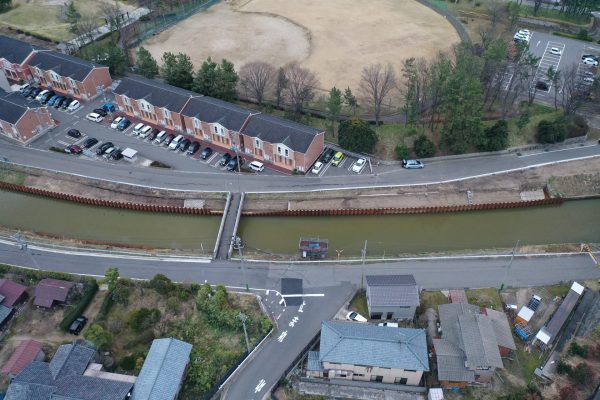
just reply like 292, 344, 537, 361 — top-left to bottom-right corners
143, 0, 459, 89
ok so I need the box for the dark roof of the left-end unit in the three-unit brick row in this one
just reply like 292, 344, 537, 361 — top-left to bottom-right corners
114, 76, 192, 113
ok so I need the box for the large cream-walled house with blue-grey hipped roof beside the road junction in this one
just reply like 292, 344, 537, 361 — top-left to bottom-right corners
307, 321, 429, 386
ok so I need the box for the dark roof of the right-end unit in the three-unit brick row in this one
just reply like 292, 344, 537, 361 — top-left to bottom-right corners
242, 114, 321, 153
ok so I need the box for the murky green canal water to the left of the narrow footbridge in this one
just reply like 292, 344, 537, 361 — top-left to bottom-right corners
0, 190, 221, 253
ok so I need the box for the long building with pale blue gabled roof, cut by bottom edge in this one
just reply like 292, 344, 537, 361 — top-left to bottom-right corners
131, 338, 192, 400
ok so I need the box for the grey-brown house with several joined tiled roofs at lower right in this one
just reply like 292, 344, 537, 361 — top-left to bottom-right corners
433, 302, 516, 387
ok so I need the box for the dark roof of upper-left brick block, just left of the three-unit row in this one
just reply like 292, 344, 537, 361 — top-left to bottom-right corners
29, 50, 106, 82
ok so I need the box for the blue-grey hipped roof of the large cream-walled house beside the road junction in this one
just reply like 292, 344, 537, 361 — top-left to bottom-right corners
319, 321, 429, 371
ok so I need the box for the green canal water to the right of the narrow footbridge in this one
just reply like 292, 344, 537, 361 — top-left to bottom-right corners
238, 199, 600, 258
